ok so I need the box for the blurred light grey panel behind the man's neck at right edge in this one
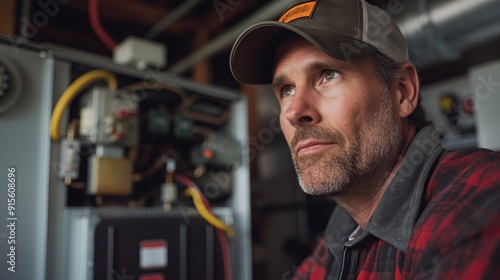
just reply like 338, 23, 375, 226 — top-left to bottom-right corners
420, 61, 500, 150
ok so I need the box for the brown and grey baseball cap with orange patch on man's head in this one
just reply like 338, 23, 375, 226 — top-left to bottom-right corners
229, 0, 409, 84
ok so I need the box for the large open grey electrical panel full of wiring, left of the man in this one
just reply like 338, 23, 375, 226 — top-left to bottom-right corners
0, 37, 251, 280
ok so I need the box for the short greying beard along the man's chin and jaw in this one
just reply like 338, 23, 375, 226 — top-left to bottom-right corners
293, 93, 402, 196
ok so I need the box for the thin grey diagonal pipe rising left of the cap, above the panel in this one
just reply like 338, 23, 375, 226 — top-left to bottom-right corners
168, 0, 292, 74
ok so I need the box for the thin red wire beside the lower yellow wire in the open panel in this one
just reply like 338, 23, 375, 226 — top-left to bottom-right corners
175, 174, 232, 280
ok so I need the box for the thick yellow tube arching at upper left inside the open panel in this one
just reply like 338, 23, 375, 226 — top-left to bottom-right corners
50, 70, 118, 141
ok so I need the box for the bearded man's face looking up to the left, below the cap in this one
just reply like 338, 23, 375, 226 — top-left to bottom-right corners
273, 39, 401, 195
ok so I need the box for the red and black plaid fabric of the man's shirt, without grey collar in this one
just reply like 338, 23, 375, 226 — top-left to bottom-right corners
294, 149, 500, 280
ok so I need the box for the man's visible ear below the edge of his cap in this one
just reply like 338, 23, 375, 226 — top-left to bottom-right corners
397, 63, 420, 118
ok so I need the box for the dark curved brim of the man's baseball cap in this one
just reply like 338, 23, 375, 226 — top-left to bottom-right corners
229, 21, 375, 84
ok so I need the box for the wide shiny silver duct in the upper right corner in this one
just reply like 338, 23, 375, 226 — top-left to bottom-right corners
392, 0, 500, 68
